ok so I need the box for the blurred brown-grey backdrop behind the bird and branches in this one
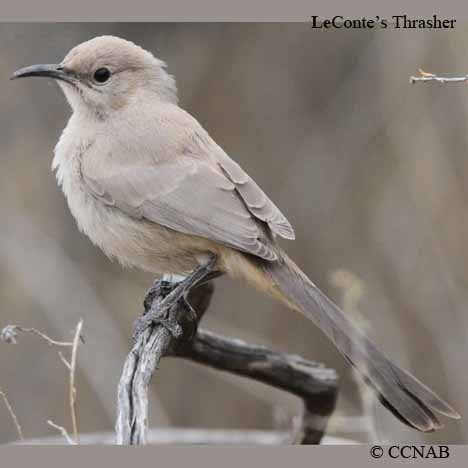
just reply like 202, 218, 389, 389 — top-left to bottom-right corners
0, 23, 468, 443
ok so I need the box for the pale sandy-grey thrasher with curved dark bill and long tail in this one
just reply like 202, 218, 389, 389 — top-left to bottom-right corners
11, 36, 460, 432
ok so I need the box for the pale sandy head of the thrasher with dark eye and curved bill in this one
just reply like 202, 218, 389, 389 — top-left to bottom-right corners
12, 36, 177, 117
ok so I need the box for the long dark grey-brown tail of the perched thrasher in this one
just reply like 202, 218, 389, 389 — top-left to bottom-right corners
228, 250, 460, 432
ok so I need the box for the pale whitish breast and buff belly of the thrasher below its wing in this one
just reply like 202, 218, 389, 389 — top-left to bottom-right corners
53, 128, 218, 274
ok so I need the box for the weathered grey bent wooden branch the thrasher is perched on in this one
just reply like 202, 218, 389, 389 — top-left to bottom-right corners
116, 260, 337, 445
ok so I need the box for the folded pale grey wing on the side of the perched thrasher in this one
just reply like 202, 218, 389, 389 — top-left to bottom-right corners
82, 157, 277, 260
